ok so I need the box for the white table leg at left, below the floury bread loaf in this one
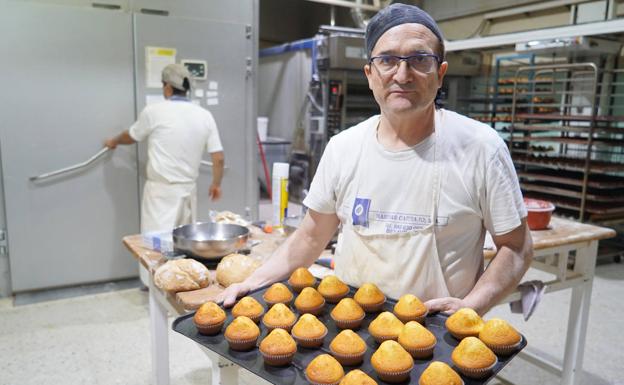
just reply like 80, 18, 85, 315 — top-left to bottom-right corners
149, 275, 169, 385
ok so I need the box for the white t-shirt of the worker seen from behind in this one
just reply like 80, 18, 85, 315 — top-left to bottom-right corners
128, 100, 223, 183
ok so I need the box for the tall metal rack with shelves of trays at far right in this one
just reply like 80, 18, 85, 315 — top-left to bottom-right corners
504, 63, 624, 223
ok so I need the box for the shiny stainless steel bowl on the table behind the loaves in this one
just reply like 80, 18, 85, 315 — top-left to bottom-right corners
173, 222, 249, 260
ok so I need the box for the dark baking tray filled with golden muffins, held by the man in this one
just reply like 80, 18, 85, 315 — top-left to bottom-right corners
172, 268, 527, 385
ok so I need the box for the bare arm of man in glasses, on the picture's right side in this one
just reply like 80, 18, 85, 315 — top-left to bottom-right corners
425, 218, 533, 315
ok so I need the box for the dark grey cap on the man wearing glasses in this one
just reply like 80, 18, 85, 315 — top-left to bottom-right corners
366, 3, 444, 60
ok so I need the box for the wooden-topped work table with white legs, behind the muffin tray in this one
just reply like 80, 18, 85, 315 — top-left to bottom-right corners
123, 218, 615, 385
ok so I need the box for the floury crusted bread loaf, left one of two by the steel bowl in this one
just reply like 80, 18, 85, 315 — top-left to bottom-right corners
154, 258, 210, 293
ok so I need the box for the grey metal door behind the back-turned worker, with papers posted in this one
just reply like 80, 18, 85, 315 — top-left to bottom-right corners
135, 11, 258, 221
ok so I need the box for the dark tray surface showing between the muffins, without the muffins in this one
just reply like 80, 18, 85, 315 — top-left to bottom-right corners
172, 281, 526, 385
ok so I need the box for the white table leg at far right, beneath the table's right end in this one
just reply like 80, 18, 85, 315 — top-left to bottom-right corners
561, 241, 598, 385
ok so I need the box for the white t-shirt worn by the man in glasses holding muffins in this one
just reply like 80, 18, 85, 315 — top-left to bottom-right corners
303, 109, 527, 298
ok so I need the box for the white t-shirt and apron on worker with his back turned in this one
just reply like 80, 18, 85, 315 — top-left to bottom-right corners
129, 98, 223, 233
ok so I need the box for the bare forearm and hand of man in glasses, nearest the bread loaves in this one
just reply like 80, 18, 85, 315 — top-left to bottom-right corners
217, 210, 339, 306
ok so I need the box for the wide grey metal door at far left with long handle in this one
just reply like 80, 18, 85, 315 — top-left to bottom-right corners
0, 1, 139, 291
